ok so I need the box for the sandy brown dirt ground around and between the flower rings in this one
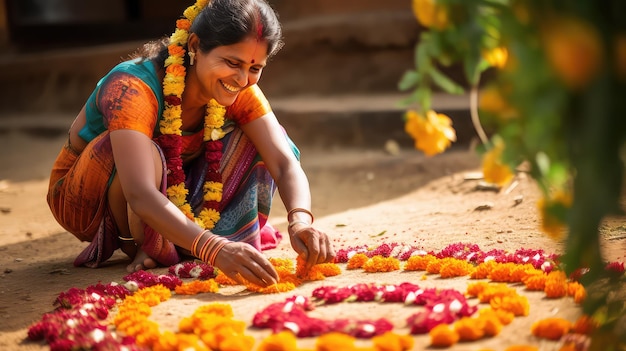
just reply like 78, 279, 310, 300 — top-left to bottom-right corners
0, 114, 626, 351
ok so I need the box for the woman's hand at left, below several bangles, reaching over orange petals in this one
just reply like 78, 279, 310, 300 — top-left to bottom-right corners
214, 242, 279, 287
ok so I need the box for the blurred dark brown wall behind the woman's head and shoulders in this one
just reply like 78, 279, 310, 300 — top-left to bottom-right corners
0, 0, 419, 113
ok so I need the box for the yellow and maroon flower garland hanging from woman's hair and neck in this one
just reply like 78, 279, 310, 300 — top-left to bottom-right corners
156, 0, 226, 230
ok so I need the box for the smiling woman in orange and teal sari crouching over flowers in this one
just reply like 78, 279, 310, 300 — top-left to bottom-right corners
48, 0, 334, 286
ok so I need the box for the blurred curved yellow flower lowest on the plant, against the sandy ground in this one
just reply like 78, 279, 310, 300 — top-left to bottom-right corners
537, 190, 573, 239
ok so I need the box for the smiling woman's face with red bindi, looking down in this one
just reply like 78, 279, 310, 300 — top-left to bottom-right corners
193, 37, 268, 106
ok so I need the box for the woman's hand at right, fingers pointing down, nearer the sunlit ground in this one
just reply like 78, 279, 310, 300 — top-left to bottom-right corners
289, 225, 335, 270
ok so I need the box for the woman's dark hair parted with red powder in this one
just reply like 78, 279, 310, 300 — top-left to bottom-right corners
136, 0, 283, 65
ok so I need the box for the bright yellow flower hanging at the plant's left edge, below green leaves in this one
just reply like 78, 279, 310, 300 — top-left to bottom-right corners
404, 110, 456, 156
